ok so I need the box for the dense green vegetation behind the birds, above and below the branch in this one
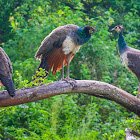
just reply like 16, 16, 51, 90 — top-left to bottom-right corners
0, 0, 140, 140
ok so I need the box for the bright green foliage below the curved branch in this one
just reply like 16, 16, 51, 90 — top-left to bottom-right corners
0, 94, 140, 140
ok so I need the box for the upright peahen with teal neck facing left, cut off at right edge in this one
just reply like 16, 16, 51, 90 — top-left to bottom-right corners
112, 25, 140, 98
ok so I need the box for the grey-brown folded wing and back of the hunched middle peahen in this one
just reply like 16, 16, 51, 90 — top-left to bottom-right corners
35, 24, 79, 59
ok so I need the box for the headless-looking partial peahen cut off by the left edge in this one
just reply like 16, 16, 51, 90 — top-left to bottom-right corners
0, 47, 15, 97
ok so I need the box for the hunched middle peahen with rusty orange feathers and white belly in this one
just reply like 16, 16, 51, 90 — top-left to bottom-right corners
35, 24, 95, 80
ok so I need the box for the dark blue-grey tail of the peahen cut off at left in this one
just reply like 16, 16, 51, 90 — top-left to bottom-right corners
1, 77, 15, 97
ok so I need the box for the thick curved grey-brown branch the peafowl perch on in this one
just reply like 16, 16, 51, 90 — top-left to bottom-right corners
0, 80, 140, 117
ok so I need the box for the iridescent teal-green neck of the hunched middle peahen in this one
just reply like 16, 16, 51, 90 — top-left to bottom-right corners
78, 28, 91, 45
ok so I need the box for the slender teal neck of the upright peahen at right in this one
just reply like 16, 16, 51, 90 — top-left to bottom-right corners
118, 30, 128, 54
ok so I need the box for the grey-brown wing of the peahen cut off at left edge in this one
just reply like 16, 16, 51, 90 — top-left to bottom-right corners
0, 47, 13, 77
